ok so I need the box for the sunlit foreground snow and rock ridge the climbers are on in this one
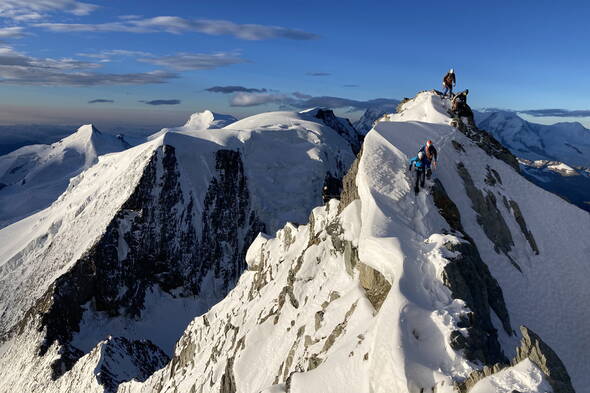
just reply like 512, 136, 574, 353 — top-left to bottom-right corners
110, 92, 590, 392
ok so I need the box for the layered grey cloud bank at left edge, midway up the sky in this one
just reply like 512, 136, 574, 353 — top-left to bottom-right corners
0, 47, 177, 86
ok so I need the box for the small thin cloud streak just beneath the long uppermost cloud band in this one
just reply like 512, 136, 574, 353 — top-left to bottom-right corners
138, 53, 246, 71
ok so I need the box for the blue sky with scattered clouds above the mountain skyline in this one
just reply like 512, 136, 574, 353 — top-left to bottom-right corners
0, 0, 590, 126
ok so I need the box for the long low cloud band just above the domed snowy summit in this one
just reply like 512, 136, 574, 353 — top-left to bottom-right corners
230, 92, 399, 110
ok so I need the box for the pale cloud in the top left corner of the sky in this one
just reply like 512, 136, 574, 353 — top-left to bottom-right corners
0, 0, 98, 22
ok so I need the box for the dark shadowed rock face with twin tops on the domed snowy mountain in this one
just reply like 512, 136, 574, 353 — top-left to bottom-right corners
33, 145, 264, 378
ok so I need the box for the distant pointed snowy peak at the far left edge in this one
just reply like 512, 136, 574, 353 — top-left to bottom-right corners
0, 124, 129, 228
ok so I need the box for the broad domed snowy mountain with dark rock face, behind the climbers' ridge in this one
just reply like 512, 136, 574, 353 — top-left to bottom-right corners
0, 108, 354, 391
